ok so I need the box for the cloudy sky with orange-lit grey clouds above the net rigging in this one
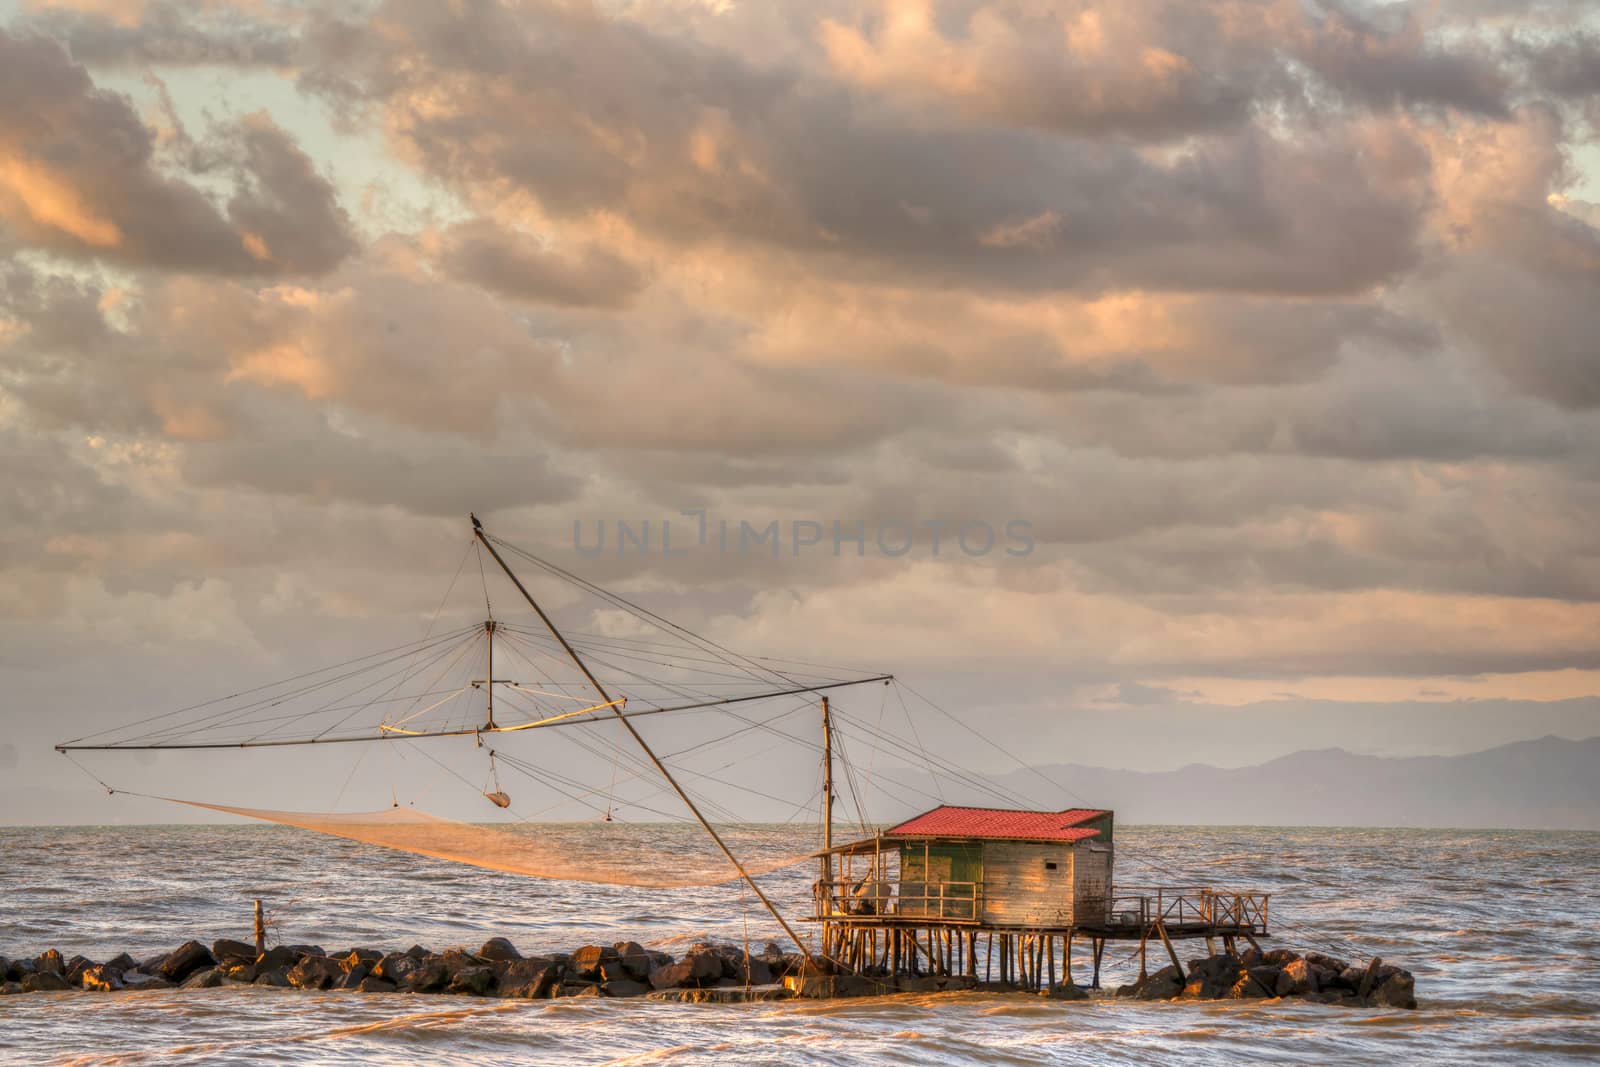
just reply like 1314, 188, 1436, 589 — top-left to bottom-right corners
0, 0, 1600, 825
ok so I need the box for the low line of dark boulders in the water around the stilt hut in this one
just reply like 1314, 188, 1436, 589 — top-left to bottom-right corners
0, 937, 1416, 1008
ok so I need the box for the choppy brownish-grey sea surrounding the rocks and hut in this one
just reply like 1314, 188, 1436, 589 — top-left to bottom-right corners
0, 824, 1600, 1067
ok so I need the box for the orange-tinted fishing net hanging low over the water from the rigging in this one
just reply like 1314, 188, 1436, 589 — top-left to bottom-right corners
162, 797, 808, 889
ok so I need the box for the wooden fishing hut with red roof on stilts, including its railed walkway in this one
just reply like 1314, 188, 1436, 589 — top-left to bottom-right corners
811, 805, 1267, 990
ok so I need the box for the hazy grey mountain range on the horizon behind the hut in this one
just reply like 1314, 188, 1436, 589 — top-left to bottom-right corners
998, 736, 1600, 830
